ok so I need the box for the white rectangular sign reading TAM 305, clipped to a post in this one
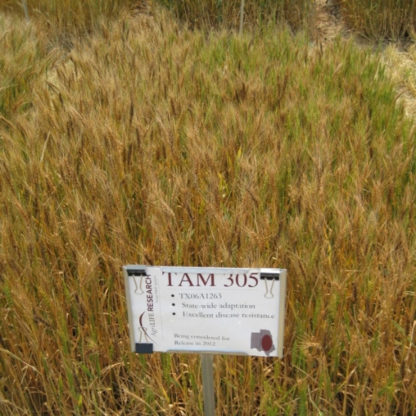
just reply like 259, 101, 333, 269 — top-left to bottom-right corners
123, 265, 286, 357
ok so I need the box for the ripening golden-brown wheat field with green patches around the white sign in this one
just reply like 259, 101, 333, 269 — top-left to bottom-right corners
0, 0, 416, 416
